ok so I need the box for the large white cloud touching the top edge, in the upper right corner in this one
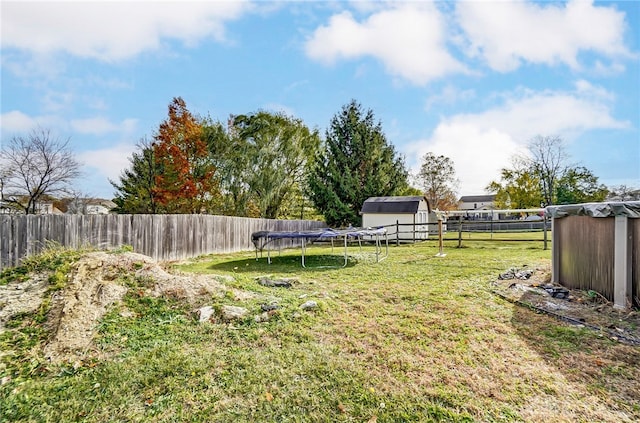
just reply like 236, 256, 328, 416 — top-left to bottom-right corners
456, 0, 631, 72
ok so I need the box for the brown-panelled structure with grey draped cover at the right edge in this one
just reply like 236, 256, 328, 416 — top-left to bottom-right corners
547, 201, 640, 308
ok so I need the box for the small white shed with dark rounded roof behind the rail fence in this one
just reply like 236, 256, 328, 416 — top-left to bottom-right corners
360, 196, 437, 240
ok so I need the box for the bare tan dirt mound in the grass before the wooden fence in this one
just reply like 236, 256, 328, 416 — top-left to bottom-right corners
0, 252, 227, 363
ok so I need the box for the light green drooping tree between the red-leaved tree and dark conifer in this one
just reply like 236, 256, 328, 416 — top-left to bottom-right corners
232, 111, 320, 219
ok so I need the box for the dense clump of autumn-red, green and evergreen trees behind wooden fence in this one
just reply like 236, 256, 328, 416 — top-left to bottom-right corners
111, 97, 410, 226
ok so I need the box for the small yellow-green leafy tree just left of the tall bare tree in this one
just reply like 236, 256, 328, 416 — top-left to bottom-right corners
486, 157, 543, 209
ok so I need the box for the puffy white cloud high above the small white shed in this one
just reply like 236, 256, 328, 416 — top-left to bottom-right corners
305, 3, 467, 85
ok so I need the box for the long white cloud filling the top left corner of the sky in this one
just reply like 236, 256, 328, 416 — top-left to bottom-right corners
1, 1, 250, 62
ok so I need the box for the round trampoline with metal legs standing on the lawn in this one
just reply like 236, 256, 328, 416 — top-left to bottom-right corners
251, 228, 389, 268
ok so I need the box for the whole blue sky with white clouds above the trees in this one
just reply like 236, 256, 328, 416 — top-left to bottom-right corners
0, 0, 640, 198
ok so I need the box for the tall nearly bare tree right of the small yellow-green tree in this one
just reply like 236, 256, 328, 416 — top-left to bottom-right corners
529, 135, 568, 206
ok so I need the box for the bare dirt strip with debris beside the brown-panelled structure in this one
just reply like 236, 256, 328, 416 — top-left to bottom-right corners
492, 266, 640, 345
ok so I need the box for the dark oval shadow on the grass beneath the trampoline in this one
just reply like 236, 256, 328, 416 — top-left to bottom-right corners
207, 254, 358, 273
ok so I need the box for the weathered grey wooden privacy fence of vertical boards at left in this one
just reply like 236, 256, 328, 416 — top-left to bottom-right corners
0, 214, 326, 269
